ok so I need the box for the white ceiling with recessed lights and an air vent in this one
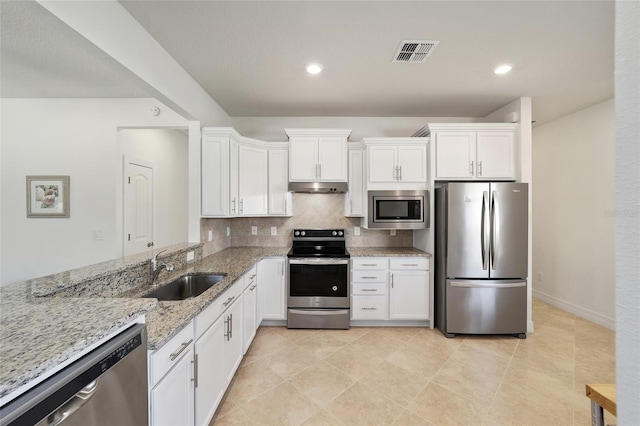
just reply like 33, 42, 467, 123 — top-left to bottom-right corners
1, 0, 614, 122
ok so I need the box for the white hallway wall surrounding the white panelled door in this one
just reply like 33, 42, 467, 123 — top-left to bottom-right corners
116, 129, 189, 251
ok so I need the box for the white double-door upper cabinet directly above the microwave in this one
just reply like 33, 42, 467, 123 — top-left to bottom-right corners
363, 138, 428, 189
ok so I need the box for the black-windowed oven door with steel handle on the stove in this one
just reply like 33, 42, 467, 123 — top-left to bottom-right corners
287, 258, 349, 308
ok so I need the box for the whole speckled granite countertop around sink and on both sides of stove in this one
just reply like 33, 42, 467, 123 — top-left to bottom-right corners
0, 244, 431, 398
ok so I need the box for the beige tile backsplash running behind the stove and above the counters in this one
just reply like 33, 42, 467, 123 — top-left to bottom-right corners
200, 193, 413, 256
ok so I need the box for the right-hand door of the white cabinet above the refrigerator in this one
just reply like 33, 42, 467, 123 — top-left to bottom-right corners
476, 132, 515, 179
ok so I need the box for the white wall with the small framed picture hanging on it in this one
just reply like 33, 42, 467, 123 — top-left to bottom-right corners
0, 99, 188, 285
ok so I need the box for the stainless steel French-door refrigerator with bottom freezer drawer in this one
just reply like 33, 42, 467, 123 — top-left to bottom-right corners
435, 182, 528, 338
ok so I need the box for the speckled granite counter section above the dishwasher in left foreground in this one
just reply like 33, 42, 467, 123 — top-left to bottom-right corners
0, 291, 156, 397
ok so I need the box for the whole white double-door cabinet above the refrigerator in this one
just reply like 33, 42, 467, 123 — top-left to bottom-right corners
429, 123, 516, 180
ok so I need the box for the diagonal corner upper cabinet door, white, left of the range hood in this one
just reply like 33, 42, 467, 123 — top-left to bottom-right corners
238, 145, 269, 216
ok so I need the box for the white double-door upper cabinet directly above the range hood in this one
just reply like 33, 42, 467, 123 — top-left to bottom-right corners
285, 129, 351, 182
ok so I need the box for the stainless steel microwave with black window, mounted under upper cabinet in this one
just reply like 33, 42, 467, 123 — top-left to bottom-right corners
368, 190, 429, 229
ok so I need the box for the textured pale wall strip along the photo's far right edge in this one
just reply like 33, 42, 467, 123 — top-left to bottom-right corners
615, 1, 640, 425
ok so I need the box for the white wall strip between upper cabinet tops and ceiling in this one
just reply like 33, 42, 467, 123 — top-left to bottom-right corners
231, 117, 479, 141
